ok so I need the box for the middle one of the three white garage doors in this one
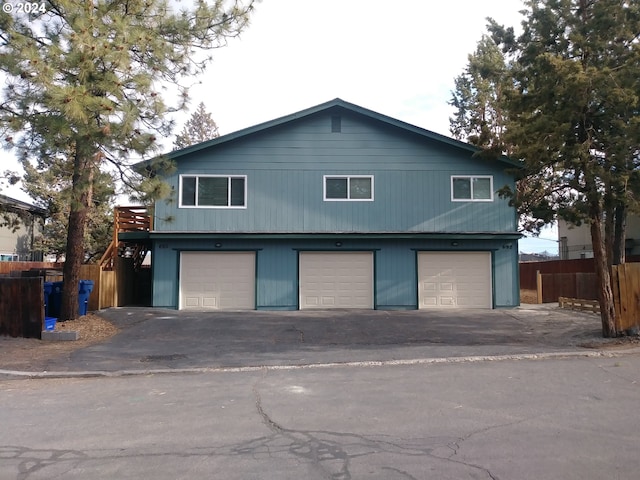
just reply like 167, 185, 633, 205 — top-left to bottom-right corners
300, 252, 373, 309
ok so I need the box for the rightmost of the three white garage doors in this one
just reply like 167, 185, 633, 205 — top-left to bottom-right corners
418, 252, 492, 308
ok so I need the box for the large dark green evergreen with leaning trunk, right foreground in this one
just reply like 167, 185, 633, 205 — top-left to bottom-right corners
491, 0, 640, 337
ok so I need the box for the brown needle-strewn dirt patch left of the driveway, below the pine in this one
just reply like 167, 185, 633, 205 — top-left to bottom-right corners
0, 313, 119, 371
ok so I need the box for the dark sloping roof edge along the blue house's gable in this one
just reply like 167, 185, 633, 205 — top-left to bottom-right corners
160, 98, 520, 167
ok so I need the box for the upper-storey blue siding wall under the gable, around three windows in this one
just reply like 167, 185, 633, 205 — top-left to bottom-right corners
154, 111, 517, 233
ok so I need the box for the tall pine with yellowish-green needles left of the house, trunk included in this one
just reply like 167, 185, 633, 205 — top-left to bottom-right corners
0, 0, 253, 320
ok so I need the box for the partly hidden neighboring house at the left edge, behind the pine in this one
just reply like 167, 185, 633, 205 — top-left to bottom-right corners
0, 195, 47, 262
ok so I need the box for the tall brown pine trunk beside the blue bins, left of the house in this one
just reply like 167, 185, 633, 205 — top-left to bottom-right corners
60, 154, 93, 321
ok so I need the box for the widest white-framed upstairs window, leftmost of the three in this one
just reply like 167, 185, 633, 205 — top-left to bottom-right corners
180, 175, 247, 208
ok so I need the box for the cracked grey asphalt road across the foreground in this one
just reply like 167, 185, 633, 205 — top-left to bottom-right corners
0, 355, 640, 480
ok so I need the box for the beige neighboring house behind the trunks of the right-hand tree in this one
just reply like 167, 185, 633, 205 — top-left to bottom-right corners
558, 215, 640, 260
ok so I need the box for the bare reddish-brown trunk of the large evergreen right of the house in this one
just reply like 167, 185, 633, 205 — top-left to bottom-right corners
591, 213, 618, 338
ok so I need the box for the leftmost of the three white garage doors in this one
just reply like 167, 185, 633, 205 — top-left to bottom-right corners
180, 252, 256, 310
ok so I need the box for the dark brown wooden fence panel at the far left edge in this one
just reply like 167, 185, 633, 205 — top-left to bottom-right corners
0, 277, 44, 338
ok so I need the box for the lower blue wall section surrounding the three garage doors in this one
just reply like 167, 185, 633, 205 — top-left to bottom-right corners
153, 236, 519, 310
